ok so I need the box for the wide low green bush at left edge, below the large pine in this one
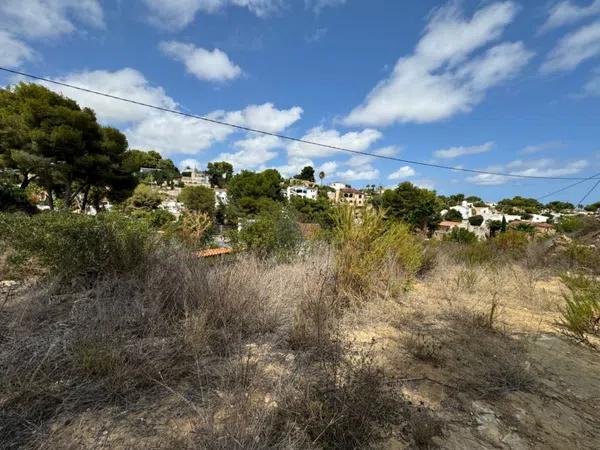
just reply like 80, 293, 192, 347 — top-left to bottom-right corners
0, 212, 156, 281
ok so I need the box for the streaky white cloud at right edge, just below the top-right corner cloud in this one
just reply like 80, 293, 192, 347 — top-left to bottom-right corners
540, 21, 600, 73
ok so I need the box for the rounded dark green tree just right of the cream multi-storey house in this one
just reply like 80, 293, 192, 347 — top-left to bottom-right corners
377, 181, 443, 231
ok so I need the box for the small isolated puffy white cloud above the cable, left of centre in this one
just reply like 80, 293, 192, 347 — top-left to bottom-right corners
159, 41, 242, 81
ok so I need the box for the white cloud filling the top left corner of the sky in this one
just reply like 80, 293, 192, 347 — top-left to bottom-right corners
0, 0, 104, 38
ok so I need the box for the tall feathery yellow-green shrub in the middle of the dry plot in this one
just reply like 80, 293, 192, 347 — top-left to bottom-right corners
334, 207, 423, 300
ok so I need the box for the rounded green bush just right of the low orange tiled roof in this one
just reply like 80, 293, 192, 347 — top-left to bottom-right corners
236, 210, 302, 257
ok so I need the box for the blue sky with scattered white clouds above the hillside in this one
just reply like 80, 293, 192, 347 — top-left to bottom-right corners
0, 0, 600, 203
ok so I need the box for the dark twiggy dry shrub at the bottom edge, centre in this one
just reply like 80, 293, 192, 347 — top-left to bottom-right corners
280, 344, 404, 449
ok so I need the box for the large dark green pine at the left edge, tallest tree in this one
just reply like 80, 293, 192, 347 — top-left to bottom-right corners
0, 83, 137, 208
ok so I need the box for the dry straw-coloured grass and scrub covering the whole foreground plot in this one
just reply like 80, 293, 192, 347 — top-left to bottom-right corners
0, 229, 596, 449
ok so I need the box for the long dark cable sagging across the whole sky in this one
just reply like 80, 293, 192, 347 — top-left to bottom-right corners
0, 63, 589, 181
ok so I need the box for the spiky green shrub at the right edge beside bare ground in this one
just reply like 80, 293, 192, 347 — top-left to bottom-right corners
561, 275, 600, 340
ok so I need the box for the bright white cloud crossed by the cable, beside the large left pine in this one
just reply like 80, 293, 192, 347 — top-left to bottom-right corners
42, 67, 177, 123
